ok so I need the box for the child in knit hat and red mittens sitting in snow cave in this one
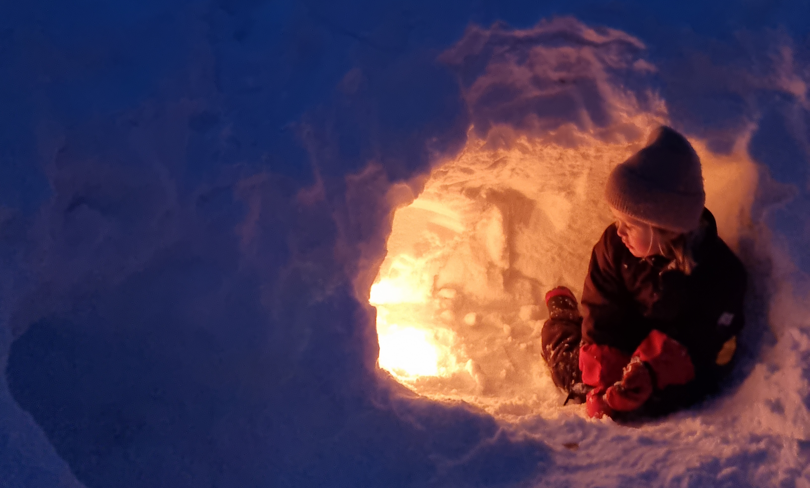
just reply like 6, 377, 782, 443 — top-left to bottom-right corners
542, 127, 746, 418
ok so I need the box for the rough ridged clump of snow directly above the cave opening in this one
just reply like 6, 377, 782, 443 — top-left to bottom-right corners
441, 17, 658, 147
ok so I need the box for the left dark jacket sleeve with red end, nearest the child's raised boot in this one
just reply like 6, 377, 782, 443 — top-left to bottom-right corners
579, 226, 640, 387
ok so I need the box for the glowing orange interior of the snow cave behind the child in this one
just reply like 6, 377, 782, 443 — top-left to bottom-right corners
369, 130, 756, 415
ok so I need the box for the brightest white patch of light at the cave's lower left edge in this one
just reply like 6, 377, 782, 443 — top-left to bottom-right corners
379, 325, 439, 378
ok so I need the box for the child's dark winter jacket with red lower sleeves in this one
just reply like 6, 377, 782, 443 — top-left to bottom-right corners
579, 210, 746, 408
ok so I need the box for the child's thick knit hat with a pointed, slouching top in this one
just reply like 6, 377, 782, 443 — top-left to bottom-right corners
605, 126, 706, 232
